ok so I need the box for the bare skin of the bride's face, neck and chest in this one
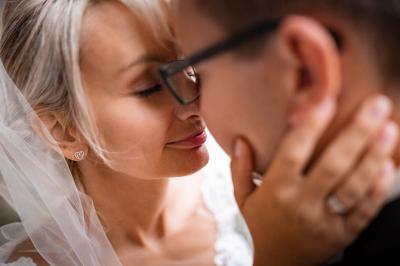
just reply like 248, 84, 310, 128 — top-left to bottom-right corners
39, 1, 217, 265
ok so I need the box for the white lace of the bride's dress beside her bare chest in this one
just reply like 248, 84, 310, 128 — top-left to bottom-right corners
202, 139, 253, 266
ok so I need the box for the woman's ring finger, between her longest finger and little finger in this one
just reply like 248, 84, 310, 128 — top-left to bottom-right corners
334, 122, 398, 212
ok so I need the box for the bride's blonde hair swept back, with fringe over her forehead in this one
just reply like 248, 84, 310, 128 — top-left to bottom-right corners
0, 0, 173, 179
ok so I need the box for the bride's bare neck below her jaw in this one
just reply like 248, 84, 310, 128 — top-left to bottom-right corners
78, 163, 170, 246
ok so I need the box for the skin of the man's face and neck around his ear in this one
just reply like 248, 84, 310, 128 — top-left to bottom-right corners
173, 0, 397, 172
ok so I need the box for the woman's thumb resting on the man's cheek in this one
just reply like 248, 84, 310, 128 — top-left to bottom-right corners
231, 138, 256, 209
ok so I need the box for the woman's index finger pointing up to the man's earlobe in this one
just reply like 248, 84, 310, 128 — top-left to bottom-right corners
266, 98, 336, 185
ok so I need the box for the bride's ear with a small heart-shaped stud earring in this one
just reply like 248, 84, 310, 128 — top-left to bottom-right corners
36, 112, 88, 161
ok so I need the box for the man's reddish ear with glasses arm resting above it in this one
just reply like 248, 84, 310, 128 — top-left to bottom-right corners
278, 15, 342, 116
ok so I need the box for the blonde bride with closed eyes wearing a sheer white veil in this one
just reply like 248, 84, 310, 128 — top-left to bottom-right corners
0, 0, 396, 266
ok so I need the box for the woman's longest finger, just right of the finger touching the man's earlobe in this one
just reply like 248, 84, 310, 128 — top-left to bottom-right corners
305, 96, 391, 199
